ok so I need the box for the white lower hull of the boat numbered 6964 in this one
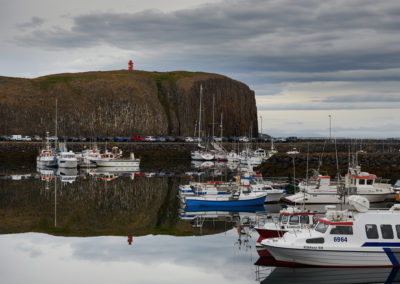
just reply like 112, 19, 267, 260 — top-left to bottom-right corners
263, 244, 400, 267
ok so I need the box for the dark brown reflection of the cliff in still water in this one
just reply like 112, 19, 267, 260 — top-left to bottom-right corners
0, 170, 212, 236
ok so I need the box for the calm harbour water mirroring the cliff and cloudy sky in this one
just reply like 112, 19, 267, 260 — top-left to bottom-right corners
0, 170, 399, 283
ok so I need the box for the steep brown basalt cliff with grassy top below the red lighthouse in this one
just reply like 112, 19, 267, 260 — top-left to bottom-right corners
0, 70, 258, 136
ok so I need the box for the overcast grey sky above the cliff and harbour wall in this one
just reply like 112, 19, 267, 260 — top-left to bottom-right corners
0, 0, 400, 137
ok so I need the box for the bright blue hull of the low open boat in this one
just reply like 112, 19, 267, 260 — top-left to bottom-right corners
185, 196, 266, 206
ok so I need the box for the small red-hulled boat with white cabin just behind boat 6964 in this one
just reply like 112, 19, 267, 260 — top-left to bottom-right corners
255, 207, 315, 244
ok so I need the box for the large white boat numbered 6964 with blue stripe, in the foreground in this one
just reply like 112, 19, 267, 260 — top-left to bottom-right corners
261, 196, 400, 267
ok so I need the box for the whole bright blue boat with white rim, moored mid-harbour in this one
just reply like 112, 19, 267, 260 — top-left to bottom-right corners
181, 188, 267, 206
